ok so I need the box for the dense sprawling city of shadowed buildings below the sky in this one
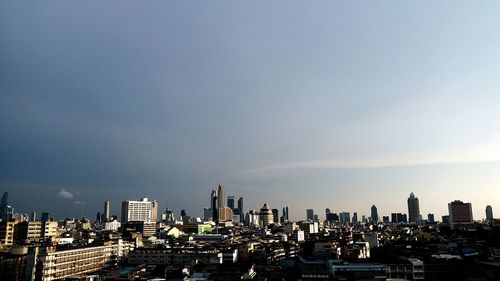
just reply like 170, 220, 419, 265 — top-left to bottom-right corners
0, 189, 500, 281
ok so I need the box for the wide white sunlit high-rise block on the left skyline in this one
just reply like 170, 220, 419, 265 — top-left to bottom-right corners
122, 198, 157, 223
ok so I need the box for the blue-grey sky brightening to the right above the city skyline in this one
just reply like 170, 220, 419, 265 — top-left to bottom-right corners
0, 0, 500, 219
